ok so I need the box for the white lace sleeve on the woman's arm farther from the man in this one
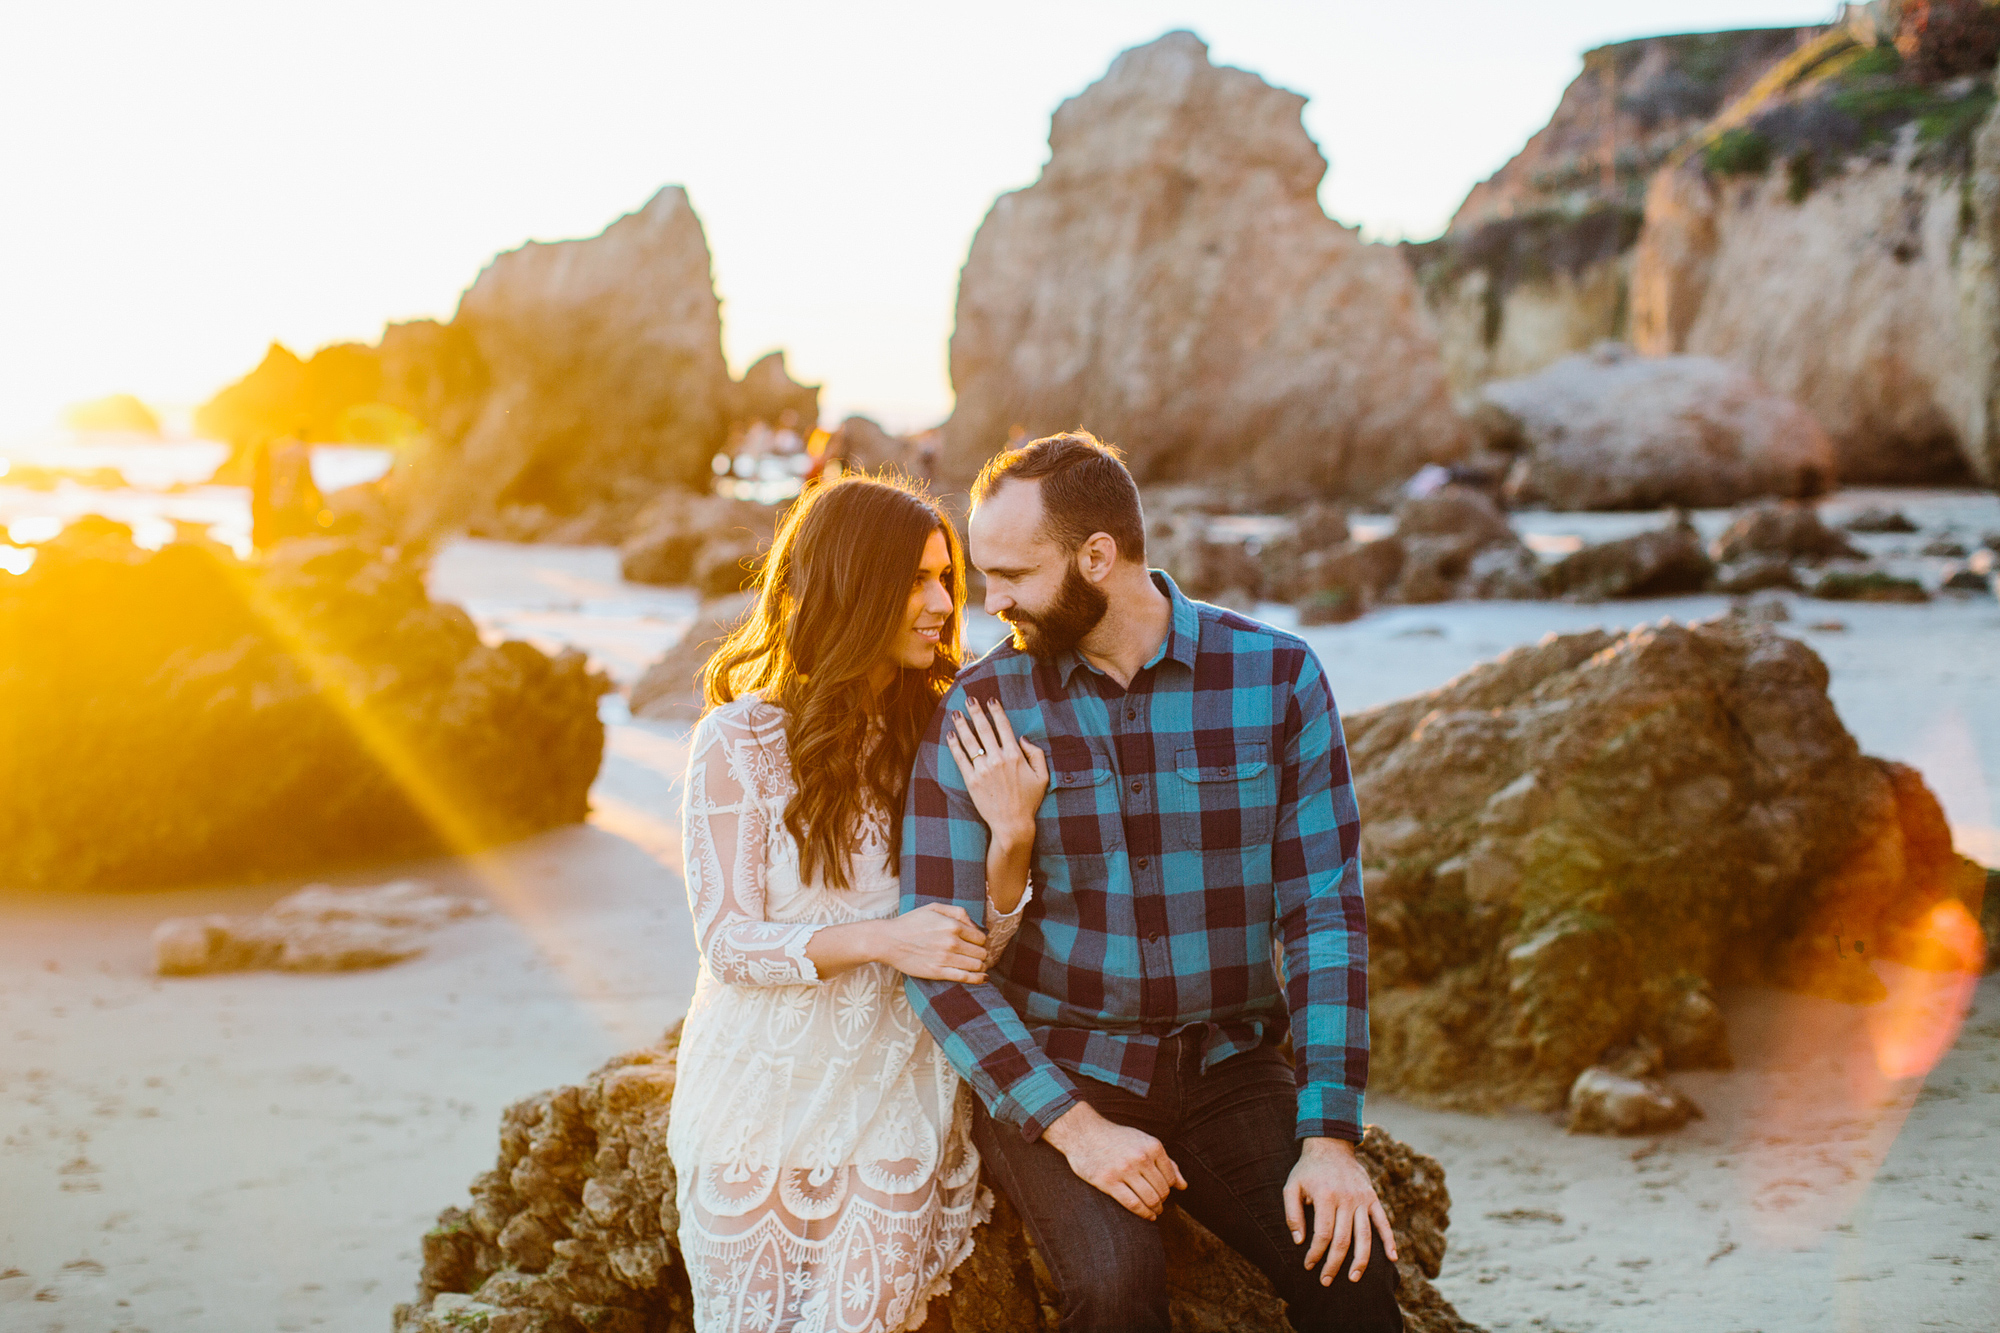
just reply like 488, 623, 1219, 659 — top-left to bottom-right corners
682, 709, 824, 987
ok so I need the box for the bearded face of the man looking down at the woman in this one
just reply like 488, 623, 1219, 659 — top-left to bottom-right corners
968, 480, 1108, 660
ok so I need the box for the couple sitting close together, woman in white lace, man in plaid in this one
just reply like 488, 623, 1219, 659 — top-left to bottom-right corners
668, 434, 1402, 1333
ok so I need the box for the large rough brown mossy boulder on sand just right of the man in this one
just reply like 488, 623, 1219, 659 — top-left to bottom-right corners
1344, 616, 1980, 1111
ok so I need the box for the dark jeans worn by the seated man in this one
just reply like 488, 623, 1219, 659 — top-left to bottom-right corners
972, 1031, 1402, 1333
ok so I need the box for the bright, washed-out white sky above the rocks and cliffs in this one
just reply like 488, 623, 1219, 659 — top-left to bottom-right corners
0, 0, 1834, 440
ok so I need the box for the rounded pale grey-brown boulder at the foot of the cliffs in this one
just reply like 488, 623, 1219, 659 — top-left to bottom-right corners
1478, 344, 1834, 508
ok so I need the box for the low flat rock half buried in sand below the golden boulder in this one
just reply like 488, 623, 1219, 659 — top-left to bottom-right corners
152, 879, 484, 977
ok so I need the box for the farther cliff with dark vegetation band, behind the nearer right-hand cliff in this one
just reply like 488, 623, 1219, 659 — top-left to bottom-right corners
1406, 28, 1820, 396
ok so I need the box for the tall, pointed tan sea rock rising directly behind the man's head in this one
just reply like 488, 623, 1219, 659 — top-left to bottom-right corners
942, 32, 1470, 502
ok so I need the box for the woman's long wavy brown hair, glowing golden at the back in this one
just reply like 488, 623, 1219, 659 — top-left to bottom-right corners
702, 476, 966, 889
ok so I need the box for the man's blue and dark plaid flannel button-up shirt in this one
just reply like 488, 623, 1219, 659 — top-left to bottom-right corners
902, 570, 1368, 1141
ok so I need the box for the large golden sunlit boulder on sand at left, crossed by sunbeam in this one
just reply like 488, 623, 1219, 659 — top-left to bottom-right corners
0, 518, 610, 889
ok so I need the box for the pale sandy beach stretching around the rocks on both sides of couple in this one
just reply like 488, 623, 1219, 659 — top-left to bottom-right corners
0, 492, 2000, 1333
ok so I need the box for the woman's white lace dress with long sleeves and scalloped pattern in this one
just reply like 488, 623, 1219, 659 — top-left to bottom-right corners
666, 699, 1028, 1333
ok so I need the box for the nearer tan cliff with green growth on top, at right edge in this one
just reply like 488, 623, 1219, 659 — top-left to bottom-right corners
1632, 32, 2000, 484
